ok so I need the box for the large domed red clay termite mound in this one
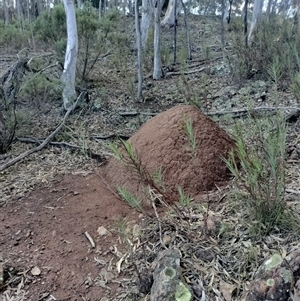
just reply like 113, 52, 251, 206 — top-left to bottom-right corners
105, 105, 235, 202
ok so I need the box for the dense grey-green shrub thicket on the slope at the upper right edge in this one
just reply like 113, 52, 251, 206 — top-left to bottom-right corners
230, 16, 300, 97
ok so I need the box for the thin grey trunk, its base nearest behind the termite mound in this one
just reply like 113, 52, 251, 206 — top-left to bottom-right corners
134, 0, 143, 101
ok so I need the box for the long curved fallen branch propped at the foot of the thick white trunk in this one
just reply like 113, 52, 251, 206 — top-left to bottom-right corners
0, 92, 85, 171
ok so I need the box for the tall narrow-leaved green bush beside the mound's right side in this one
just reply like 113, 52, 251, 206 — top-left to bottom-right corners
224, 115, 295, 234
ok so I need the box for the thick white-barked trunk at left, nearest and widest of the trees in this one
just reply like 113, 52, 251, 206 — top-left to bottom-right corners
62, 0, 78, 110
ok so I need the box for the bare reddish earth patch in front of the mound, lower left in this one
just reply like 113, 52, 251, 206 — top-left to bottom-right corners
0, 170, 139, 300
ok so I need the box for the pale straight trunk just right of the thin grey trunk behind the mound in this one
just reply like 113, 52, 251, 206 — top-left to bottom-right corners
153, 0, 162, 79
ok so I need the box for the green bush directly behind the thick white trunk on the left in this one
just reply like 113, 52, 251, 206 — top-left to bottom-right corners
34, 1, 128, 80
